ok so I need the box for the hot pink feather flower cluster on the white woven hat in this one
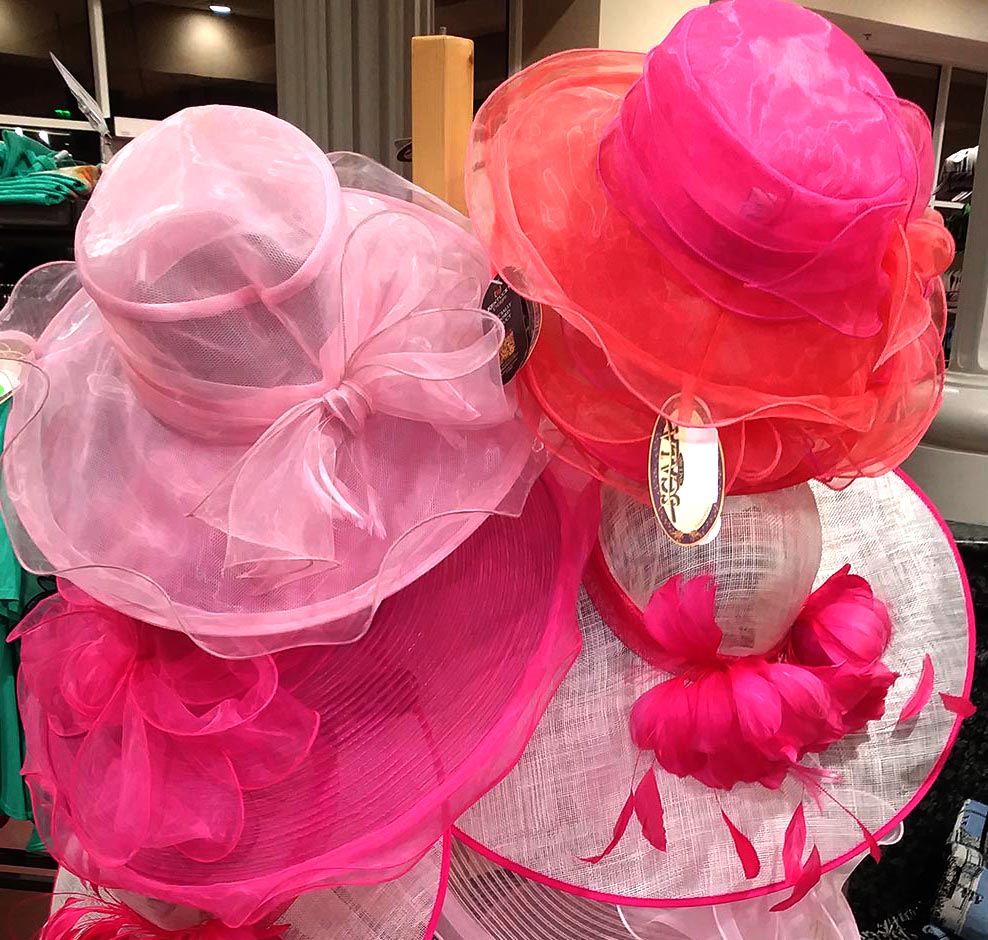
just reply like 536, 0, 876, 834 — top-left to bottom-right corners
631, 566, 897, 790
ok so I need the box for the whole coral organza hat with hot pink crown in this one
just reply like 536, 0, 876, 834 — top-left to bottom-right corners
467, 0, 953, 497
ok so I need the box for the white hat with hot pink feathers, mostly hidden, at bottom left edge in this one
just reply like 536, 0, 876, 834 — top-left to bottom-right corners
42, 837, 449, 940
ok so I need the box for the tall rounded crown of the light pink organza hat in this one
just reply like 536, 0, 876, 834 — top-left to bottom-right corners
76, 106, 346, 440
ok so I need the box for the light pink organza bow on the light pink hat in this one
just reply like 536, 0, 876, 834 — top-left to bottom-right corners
194, 211, 512, 588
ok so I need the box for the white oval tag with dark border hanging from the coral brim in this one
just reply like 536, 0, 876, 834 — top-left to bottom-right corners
648, 402, 724, 545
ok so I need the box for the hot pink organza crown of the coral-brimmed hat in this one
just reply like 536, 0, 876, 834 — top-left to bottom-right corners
600, 0, 933, 336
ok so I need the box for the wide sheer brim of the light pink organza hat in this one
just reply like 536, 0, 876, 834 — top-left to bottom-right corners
2, 265, 545, 656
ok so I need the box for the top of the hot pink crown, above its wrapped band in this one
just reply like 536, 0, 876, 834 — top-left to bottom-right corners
668, 0, 916, 202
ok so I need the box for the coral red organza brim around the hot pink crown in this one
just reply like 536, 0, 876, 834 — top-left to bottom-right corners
467, 50, 949, 493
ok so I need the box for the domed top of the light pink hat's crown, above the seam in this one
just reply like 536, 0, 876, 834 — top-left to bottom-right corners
76, 105, 342, 306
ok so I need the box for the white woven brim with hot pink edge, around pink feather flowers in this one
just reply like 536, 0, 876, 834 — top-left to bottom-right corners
458, 475, 974, 907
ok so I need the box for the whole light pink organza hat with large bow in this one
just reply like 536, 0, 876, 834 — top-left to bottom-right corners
0, 106, 544, 656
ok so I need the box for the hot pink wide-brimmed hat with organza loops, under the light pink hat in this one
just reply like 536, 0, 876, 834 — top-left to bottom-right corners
17, 475, 598, 936
